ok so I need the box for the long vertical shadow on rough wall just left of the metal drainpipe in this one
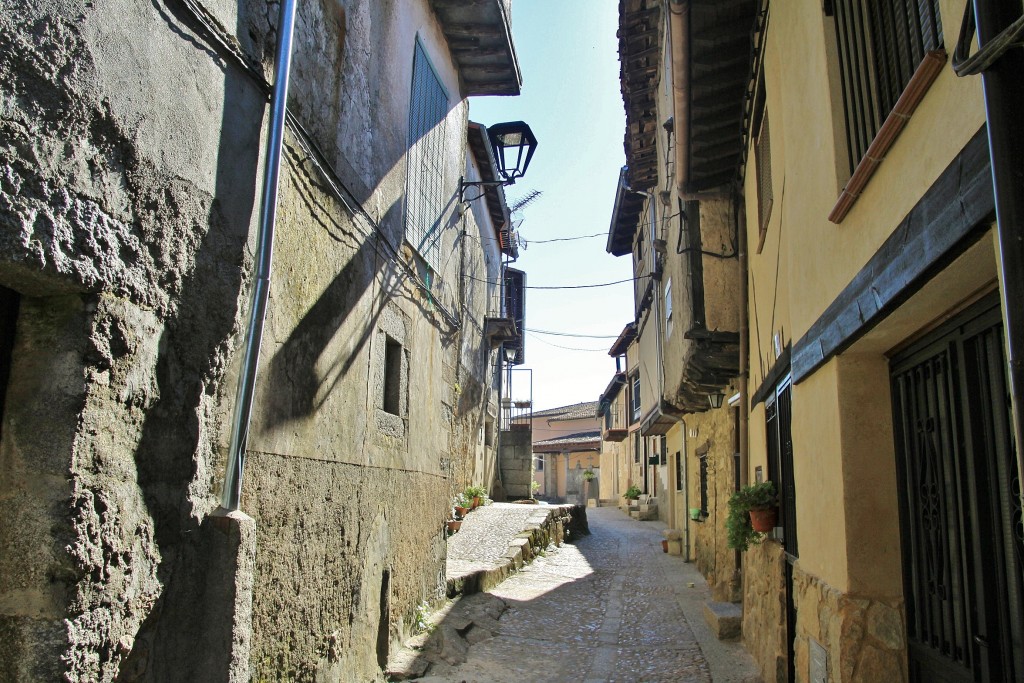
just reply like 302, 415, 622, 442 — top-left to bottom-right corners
114, 0, 266, 681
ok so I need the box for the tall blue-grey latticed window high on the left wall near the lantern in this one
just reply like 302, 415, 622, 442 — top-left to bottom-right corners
406, 40, 449, 272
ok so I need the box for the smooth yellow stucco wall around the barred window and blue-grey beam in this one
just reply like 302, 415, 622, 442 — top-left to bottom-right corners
744, 0, 994, 594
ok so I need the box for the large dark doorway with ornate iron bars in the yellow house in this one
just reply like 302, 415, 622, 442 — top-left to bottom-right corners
891, 296, 1024, 682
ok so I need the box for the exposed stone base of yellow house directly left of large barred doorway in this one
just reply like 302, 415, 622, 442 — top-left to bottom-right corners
794, 564, 907, 683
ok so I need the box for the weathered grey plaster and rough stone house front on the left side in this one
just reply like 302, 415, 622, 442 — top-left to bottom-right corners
0, 0, 520, 681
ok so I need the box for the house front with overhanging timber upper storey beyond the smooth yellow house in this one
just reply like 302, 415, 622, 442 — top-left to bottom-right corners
606, 0, 743, 600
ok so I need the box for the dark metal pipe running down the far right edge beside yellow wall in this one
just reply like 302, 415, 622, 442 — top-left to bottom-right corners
973, 0, 1024, 496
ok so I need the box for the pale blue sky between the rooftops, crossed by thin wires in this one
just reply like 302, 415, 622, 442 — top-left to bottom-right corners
469, 0, 633, 410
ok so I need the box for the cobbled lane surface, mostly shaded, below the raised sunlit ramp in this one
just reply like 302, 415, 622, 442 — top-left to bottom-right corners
403, 508, 759, 683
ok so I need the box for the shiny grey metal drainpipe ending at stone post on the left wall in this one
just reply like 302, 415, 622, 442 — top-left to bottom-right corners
220, 0, 295, 511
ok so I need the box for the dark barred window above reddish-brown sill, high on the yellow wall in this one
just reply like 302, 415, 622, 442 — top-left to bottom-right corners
825, 0, 943, 172
